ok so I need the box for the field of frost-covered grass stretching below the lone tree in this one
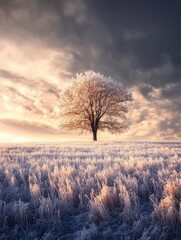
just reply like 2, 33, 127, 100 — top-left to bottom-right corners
0, 142, 181, 240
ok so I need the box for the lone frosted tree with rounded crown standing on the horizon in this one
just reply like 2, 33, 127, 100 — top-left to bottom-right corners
61, 71, 131, 141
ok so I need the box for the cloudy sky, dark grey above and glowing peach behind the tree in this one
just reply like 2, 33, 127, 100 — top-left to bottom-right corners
0, 0, 181, 142
